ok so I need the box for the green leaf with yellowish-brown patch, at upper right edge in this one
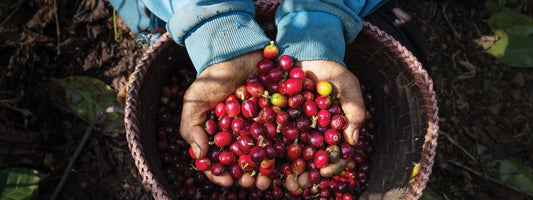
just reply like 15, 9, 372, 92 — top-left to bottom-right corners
486, 8, 533, 68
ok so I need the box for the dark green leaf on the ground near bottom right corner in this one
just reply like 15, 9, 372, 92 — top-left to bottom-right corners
489, 156, 533, 194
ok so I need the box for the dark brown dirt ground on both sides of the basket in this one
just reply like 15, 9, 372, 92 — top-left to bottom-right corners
0, 0, 533, 199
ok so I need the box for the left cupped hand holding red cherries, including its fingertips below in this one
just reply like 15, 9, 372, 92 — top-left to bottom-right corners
180, 51, 271, 189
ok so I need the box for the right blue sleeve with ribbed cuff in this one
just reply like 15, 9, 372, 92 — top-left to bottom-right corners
276, 0, 386, 65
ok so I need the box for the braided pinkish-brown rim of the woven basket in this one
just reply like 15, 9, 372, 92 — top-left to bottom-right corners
124, 20, 439, 200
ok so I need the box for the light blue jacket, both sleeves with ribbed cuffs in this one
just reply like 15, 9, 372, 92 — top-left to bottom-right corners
110, 0, 386, 74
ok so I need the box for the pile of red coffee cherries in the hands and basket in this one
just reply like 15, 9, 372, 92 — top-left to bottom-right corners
157, 43, 375, 199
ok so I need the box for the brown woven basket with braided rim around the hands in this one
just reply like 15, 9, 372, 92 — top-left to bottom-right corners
125, 11, 439, 200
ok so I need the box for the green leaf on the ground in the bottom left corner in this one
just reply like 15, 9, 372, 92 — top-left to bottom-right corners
0, 168, 48, 200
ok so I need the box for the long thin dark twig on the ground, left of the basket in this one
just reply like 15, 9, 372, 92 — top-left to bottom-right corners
50, 107, 125, 200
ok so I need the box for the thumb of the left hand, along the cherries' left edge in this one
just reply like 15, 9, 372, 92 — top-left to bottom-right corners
180, 82, 209, 158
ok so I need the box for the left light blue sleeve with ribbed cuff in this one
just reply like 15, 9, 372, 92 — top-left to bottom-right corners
139, 0, 270, 74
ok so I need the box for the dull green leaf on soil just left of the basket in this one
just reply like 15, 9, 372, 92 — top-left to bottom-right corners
55, 76, 121, 122
